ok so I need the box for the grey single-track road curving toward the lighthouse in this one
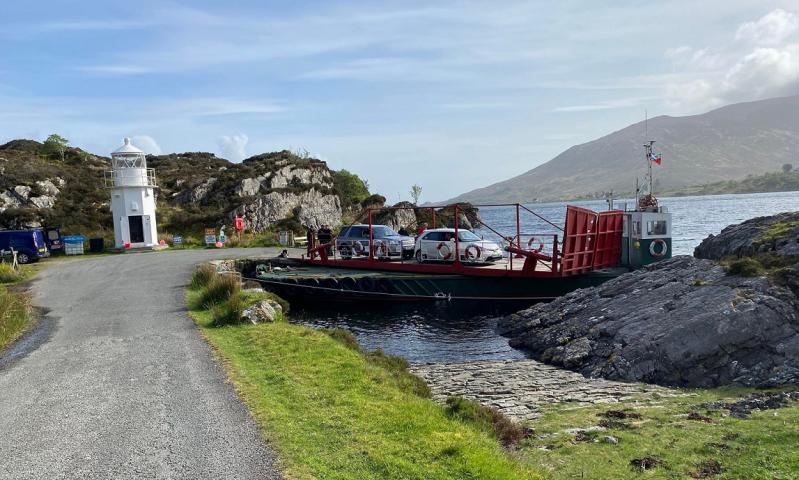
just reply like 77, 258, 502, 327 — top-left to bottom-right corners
0, 249, 288, 479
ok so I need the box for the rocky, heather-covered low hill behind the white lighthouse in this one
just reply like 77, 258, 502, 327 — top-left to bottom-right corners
0, 140, 382, 238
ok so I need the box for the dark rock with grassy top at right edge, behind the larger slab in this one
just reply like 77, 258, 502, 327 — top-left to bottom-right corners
694, 212, 799, 260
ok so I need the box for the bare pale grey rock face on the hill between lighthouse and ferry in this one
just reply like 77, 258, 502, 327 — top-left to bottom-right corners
229, 188, 342, 232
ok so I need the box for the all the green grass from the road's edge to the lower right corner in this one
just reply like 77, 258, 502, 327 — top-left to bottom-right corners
187, 268, 799, 480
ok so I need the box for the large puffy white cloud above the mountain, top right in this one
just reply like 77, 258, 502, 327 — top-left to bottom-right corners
664, 9, 799, 112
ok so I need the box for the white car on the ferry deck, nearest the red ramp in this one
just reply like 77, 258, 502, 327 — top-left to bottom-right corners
414, 228, 504, 263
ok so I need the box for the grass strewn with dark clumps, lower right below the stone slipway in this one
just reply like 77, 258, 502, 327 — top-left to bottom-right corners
519, 389, 799, 480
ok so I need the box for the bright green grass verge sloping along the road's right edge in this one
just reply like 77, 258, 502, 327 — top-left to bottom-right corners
188, 291, 541, 480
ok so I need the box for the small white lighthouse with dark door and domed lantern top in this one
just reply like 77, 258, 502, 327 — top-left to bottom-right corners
106, 138, 158, 248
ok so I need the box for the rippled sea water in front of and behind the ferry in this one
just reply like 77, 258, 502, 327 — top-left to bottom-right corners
292, 192, 799, 362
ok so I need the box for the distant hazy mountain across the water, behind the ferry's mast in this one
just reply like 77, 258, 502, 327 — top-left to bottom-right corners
449, 96, 799, 203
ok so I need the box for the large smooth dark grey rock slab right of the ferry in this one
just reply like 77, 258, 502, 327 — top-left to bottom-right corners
499, 256, 799, 387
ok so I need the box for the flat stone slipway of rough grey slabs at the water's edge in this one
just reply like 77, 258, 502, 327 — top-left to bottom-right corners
411, 360, 676, 420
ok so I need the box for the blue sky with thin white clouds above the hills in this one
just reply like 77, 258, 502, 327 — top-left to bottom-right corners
0, 0, 799, 201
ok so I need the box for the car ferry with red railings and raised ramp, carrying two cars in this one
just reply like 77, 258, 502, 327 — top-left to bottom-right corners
252, 142, 671, 302
